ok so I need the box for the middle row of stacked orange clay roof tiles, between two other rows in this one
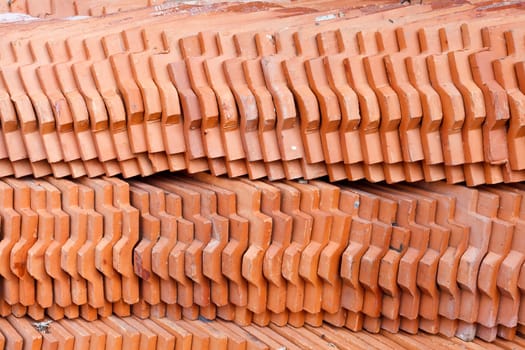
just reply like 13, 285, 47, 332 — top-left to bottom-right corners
0, 174, 525, 341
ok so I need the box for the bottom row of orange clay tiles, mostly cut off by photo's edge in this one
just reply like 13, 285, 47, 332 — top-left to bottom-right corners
0, 316, 525, 350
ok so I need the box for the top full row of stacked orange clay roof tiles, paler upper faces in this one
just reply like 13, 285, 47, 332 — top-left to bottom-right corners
0, 1, 525, 185
